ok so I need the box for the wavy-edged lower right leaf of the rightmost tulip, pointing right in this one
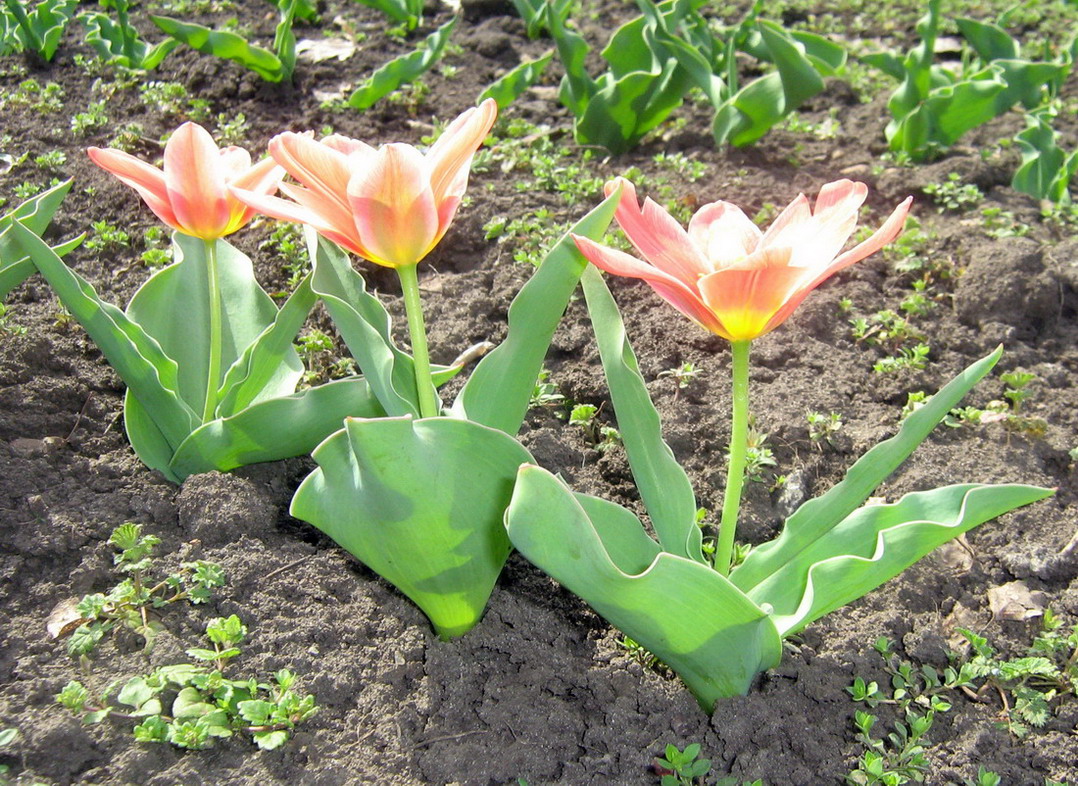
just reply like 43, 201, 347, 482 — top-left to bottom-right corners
735, 484, 1053, 636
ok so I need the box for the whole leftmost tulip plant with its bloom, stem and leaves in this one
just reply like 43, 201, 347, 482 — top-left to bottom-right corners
12, 123, 403, 483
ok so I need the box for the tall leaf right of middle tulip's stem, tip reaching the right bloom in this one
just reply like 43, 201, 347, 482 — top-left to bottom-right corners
453, 191, 621, 436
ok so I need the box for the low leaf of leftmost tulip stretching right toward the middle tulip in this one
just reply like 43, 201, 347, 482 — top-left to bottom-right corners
168, 376, 385, 483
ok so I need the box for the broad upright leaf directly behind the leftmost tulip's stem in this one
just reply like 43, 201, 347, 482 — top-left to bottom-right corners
126, 232, 282, 420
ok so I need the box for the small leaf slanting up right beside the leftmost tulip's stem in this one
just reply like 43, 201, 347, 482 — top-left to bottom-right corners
217, 275, 316, 417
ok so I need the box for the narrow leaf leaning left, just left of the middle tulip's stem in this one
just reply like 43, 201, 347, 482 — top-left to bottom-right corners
307, 230, 419, 415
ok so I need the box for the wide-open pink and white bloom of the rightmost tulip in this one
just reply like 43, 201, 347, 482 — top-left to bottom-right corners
573, 178, 912, 341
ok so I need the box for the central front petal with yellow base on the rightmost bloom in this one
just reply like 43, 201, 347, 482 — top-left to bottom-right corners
700, 248, 805, 341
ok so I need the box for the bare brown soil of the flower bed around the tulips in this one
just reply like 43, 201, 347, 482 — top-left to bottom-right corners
0, 0, 1078, 786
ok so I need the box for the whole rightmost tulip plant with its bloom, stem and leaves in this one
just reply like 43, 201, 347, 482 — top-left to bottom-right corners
506, 180, 1051, 712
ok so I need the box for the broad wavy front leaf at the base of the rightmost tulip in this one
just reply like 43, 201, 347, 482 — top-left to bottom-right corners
506, 466, 783, 713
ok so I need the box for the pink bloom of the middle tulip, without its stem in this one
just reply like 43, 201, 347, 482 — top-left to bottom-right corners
233, 99, 498, 267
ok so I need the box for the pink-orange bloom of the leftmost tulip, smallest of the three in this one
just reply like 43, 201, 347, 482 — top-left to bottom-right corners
86, 123, 285, 240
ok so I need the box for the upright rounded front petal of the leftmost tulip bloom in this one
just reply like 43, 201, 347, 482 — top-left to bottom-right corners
165, 123, 231, 239
